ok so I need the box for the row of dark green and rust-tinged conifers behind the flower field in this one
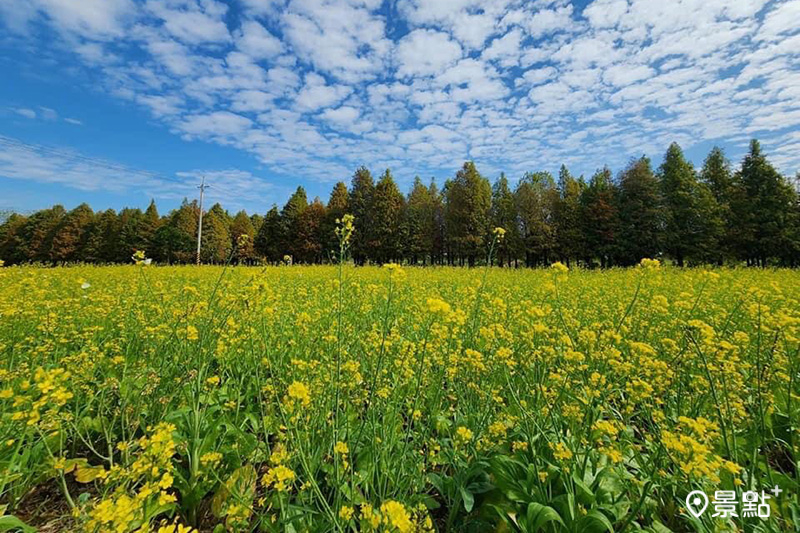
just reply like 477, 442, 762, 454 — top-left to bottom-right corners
0, 140, 800, 267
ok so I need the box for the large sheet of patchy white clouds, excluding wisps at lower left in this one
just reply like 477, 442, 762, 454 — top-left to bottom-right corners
0, 0, 800, 191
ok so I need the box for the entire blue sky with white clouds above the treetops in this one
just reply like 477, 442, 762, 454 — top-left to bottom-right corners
0, 0, 800, 212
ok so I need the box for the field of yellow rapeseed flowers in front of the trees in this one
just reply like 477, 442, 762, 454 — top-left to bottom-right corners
0, 255, 800, 533
